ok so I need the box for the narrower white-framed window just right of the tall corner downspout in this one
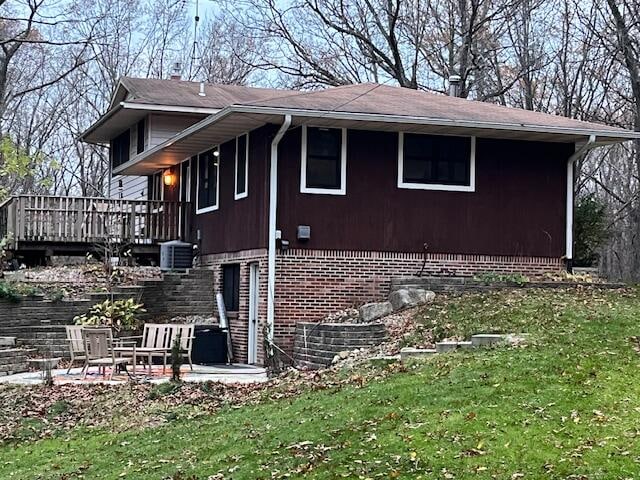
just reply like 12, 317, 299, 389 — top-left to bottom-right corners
300, 126, 347, 195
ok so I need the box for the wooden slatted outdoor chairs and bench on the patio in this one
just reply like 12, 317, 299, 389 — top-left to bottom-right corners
66, 323, 194, 379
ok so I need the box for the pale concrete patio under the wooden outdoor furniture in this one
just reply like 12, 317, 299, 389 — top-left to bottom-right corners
0, 363, 267, 385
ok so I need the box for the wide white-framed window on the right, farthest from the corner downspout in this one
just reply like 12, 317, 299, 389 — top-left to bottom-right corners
398, 133, 475, 192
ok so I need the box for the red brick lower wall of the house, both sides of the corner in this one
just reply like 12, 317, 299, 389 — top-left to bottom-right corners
203, 249, 564, 361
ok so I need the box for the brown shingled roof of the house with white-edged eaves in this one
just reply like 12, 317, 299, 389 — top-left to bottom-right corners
83, 77, 640, 174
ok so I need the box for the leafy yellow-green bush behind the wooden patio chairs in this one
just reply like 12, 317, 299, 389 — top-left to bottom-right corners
73, 298, 146, 332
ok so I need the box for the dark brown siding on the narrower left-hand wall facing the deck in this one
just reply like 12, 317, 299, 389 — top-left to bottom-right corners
191, 126, 273, 254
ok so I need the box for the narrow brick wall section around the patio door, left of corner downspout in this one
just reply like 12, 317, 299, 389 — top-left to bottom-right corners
202, 249, 267, 363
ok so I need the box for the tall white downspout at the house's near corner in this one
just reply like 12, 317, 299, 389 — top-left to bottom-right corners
267, 115, 291, 344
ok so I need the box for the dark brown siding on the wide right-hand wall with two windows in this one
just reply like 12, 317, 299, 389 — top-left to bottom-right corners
278, 129, 573, 257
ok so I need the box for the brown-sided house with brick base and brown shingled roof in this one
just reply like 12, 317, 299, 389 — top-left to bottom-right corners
83, 78, 640, 363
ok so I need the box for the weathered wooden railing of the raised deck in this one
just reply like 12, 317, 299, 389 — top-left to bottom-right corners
0, 195, 190, 248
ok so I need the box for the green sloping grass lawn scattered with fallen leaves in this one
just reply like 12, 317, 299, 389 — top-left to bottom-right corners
0, 290, 640, 480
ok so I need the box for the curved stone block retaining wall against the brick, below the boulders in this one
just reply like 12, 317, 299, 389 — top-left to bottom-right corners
293, 322, 387, 369
